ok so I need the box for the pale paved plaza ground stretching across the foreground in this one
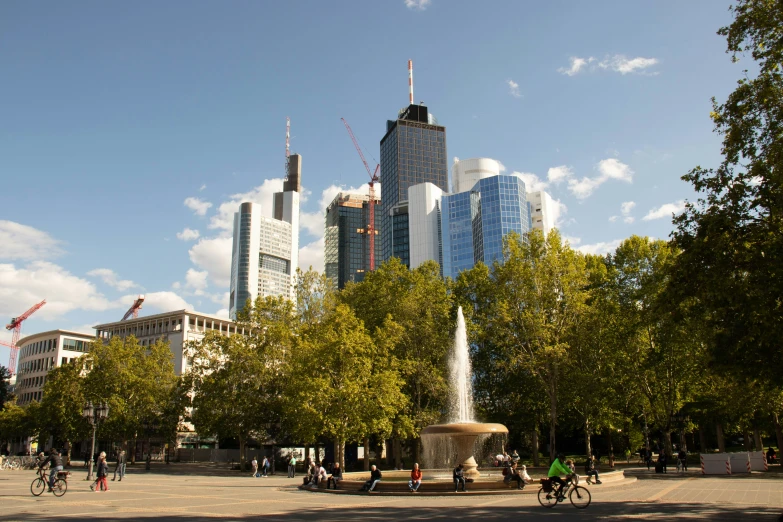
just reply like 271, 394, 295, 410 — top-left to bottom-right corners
0, 464, 783, 522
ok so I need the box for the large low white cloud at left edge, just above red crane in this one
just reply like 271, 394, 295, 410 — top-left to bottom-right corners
0, 261, 122, 320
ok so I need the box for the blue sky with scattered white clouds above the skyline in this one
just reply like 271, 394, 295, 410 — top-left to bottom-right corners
0, 0, 747, 364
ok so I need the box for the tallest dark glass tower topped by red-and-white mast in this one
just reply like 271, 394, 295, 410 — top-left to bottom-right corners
375, 105, 449, 266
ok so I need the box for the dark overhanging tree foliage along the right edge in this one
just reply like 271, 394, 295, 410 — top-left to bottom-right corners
674, 0, 783, 386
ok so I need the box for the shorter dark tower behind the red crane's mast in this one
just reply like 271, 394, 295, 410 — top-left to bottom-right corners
324, 192, 381, 288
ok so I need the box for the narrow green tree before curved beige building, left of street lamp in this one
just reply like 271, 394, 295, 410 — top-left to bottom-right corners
38, 363, 90, 463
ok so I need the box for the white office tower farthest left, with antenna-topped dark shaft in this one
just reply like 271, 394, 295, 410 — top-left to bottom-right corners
229, 201, 299, 319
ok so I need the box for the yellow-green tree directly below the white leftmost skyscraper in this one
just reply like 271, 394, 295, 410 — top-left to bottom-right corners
187, 297, 297, 469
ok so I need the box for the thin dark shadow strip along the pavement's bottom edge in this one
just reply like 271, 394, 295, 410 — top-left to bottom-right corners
7, 502, 781, 522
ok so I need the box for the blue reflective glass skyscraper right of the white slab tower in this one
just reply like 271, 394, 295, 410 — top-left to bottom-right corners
441, 174, 532, 278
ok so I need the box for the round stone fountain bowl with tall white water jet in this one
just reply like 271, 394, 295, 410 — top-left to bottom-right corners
421, 307, 508, 480
